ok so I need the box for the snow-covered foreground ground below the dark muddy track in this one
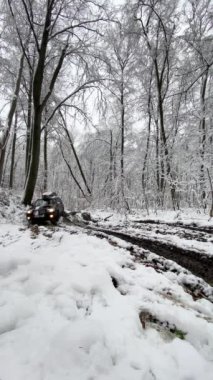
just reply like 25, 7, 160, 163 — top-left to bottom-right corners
0, 223, 213, 380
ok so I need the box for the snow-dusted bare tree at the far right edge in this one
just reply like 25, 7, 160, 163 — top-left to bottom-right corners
183, 0, 213, 208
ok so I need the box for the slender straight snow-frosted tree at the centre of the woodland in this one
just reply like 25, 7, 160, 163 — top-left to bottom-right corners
100, 22, 137, 210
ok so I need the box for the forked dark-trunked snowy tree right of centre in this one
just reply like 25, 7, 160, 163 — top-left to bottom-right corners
134, 0, 180, 208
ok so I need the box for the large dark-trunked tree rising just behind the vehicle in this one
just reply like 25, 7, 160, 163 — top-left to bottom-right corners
9, 0, 107, 204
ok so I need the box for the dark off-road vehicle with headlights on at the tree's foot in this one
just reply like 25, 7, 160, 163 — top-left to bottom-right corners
26, 192, 64, 224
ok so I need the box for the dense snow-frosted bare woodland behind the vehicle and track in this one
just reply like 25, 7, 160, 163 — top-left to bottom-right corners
0, 0, 213, 216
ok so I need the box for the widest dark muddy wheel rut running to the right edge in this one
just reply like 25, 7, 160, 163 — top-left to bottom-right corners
84, 226, 213, 285
